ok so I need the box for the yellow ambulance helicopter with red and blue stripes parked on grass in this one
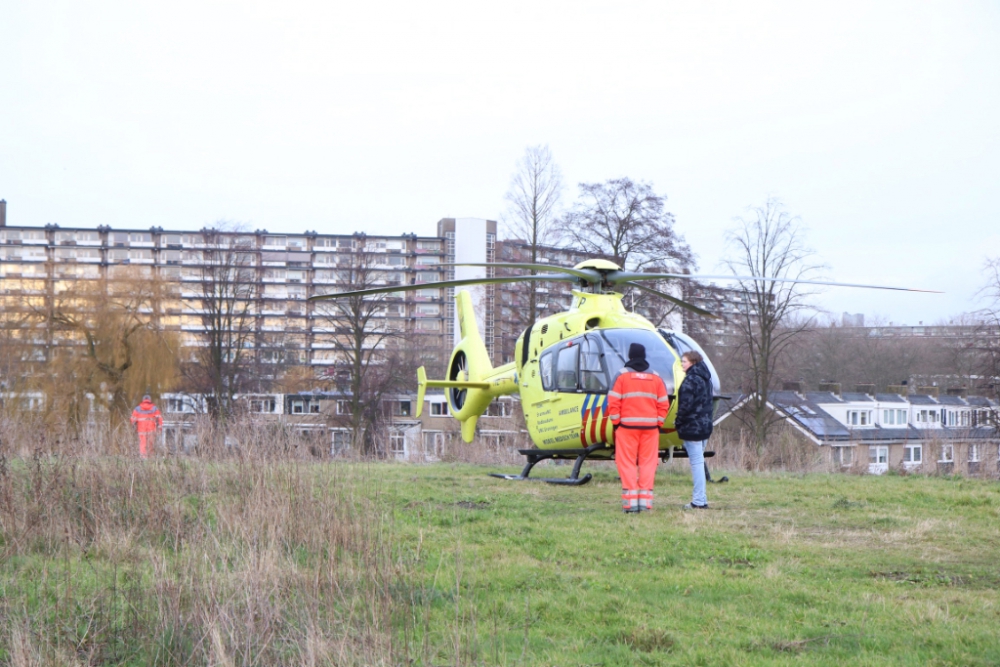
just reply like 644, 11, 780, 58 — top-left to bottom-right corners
312, 259, 936, 485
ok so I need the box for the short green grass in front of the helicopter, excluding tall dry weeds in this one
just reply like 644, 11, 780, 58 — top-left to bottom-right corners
377, 465, 1000, 667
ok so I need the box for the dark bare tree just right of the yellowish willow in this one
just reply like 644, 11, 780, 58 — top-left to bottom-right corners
189, 223, 260, 420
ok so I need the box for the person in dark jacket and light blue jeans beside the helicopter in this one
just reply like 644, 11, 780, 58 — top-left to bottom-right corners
674, 350, 712, 509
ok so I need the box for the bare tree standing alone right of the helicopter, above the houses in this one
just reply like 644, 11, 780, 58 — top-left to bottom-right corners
725, 199, 821, 455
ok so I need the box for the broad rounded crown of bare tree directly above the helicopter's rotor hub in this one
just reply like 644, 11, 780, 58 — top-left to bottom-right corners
559, 178, 694, 271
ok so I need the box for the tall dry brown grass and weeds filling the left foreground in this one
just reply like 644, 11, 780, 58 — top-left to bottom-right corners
0, 441, 406, 665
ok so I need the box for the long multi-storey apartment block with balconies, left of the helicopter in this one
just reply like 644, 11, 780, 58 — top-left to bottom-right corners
0, 218, 496, 369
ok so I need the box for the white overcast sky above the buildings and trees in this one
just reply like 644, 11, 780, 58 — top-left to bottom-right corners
0, 0, 1000, 324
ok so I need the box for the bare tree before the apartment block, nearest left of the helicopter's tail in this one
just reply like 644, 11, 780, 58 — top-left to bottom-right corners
317, 248, 408, 455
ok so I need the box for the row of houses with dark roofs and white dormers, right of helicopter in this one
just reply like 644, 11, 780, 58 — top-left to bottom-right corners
715, 386, 1000, 474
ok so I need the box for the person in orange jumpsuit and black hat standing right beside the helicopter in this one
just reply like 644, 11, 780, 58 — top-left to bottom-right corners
608, 343, 670, 514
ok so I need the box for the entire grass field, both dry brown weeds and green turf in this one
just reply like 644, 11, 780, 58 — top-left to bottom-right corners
0, 460, 1000, 665
